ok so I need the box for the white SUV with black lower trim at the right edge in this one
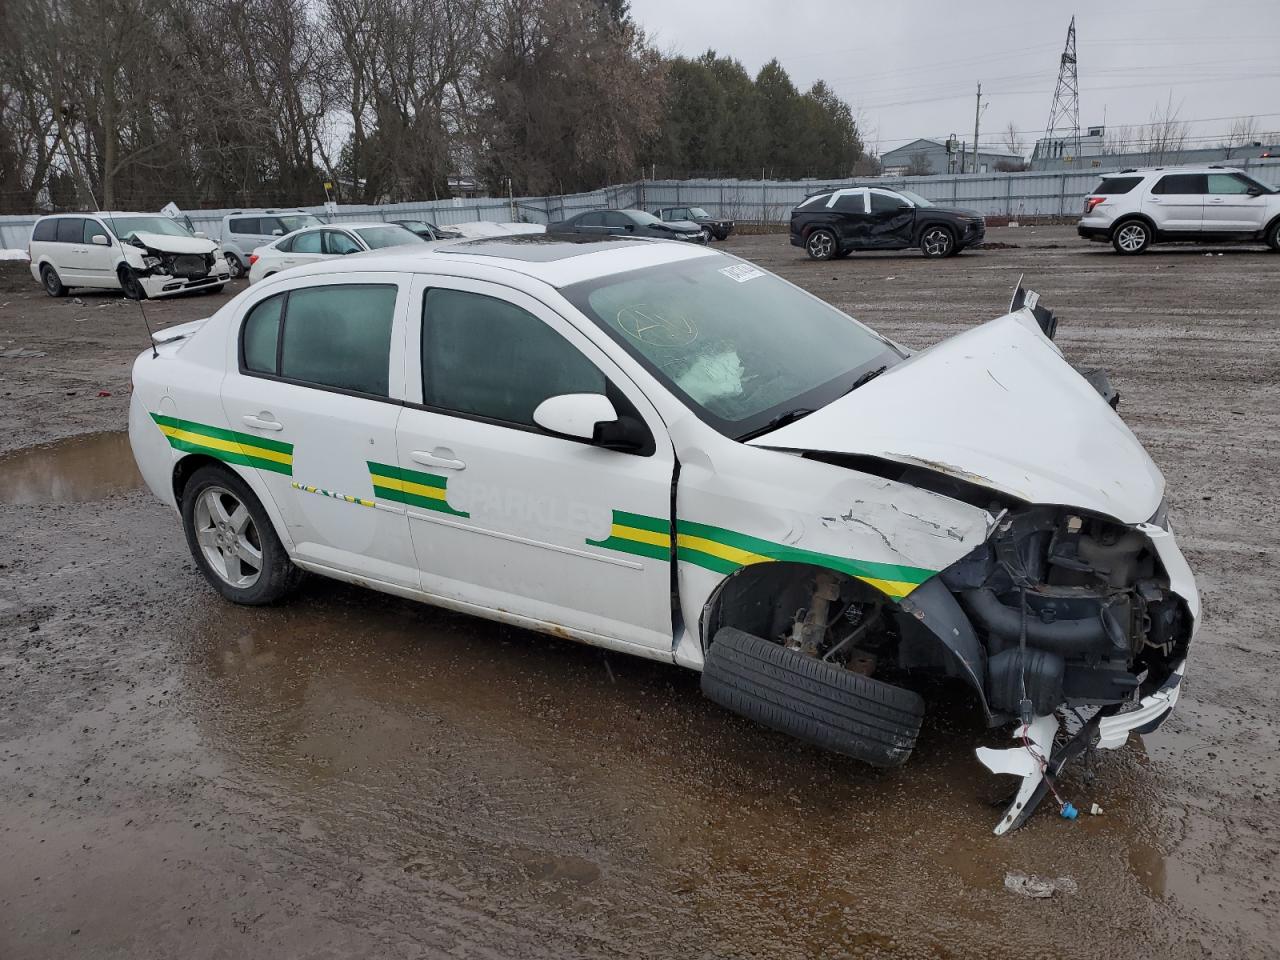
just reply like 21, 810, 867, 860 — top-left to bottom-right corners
1076, 166, 1280, 253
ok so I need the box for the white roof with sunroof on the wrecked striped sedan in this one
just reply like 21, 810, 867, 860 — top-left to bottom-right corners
276, 233, 724, 288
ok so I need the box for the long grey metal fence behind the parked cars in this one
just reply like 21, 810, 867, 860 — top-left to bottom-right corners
0, 157, 1280, 250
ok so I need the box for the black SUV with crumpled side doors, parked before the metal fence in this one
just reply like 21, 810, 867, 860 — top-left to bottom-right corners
791, 187, 987, 260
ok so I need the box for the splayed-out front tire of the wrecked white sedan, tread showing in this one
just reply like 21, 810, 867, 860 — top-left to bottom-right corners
701, 627, 924, 767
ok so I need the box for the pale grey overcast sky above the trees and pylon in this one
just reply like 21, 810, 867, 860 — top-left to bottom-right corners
631, 0, 1280, 152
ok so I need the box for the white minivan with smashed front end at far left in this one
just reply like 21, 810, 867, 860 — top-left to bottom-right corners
28, 211, 230, 300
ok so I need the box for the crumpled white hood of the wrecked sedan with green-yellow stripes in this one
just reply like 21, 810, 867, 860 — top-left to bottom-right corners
750, 311, 1165, 524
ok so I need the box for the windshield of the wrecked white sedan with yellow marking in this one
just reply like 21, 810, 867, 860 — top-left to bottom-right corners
562, 255, 901, 439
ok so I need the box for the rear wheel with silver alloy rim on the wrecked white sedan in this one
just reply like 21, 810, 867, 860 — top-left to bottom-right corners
182, 465, 302, 607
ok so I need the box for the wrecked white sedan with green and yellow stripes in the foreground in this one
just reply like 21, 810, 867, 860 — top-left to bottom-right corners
129, 236, 1199, 832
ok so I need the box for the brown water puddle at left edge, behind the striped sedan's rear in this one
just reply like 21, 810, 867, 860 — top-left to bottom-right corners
0, 430, 142, 506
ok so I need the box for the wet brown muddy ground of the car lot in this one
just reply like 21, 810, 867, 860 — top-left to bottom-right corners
0, 228, 1280, 960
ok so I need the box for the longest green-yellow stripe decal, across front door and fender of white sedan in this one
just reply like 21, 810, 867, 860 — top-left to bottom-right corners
586, 509, 936, 600
